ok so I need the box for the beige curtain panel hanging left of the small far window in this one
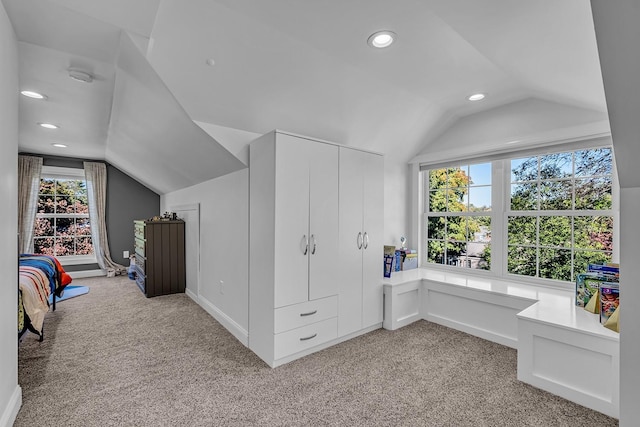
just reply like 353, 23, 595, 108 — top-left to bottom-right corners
18, 155, 42, 254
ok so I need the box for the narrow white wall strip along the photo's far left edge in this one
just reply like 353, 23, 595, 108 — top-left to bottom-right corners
0, 3, 22, 427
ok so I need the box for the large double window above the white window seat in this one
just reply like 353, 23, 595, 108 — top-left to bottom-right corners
423, 147, 614, 282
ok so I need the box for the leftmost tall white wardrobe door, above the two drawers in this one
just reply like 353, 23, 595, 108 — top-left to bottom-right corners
272, 134, 311, 307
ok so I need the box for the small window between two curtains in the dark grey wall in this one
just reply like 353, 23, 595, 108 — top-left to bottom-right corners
33, 166, 93, 257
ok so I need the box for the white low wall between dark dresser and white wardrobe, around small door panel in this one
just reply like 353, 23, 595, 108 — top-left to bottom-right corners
160, 169, 249, 342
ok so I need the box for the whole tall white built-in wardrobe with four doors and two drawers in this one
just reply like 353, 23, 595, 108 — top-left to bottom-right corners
249, 131, 383, 366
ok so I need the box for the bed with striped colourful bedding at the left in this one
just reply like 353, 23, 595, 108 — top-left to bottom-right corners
18, 254, 72, 341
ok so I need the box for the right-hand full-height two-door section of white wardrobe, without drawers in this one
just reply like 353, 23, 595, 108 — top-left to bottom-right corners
338, 147, 384, 336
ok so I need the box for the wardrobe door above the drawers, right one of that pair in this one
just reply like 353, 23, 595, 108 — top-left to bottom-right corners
309, 143, 338, 300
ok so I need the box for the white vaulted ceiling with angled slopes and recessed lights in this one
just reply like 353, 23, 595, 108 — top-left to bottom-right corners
3, 0, 606, 193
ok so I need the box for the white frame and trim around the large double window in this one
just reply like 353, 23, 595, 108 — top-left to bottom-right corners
414, 142, 620, 289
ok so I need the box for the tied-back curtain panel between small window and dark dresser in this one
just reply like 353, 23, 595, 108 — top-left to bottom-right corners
84, 162, 127, 276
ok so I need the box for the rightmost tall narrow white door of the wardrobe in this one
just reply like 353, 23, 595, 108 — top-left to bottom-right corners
362, 153, 384, 328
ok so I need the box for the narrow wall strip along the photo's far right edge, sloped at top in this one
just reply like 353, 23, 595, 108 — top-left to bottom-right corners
591, 0, 640, 427
